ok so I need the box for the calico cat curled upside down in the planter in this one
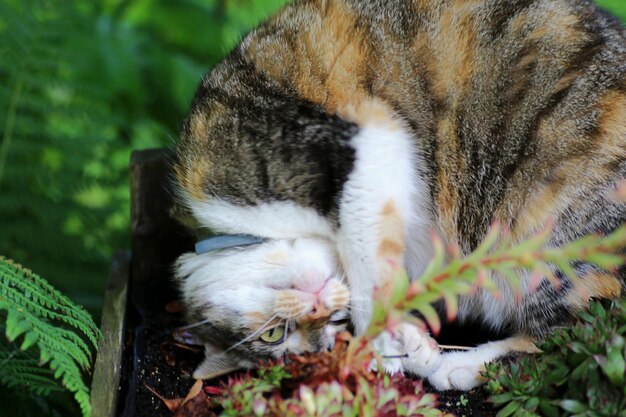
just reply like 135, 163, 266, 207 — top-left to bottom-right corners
174, 0, 626, 389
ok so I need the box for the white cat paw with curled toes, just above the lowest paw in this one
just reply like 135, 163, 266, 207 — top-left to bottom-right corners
395, 323, 441, 376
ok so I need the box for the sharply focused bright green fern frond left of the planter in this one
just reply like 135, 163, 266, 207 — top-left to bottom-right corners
0, 256, 102, 416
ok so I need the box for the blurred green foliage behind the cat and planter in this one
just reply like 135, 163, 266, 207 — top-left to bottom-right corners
0, 0, 626, 415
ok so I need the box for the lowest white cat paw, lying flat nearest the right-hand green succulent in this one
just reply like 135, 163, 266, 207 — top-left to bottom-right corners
428, 358, 485, 391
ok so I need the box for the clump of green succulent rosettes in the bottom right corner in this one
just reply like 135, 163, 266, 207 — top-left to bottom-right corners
486, 300, 626, 417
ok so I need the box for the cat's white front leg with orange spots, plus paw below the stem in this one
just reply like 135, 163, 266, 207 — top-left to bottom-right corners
337, 102, 439, 373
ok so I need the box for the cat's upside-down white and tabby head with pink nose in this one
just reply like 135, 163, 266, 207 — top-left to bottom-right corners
176, 239, 350, 378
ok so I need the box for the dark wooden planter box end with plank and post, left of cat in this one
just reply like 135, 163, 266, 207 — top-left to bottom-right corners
92, 149, 195, 417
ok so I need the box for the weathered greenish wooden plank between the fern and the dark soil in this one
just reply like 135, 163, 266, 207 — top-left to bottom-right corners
91, 251, 130, 417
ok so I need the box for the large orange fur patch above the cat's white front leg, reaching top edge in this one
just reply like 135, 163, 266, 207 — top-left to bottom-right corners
254, 2, 369, 117
